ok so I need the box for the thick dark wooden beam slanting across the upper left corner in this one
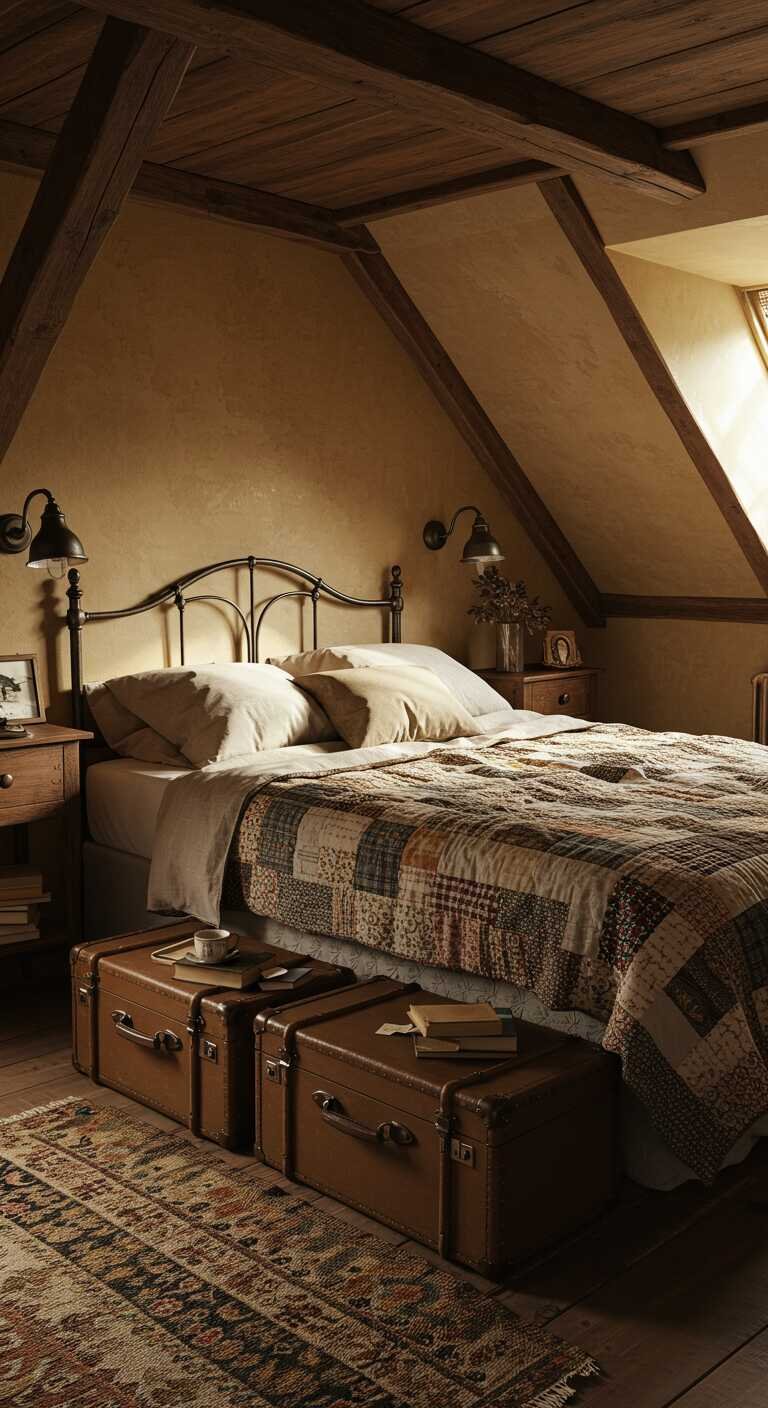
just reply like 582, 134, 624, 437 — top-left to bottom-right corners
0, 20, 194, 459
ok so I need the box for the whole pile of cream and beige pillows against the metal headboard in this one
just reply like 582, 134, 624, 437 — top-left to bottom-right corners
86, 645, 509, 767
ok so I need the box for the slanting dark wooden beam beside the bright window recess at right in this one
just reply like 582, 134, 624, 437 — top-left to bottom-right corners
540, 176, 768, 591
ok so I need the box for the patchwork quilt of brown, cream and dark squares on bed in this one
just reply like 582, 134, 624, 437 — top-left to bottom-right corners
227, 724, 768, 1181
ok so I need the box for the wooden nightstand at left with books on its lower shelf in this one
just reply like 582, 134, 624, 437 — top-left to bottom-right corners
0, 724, 93, 959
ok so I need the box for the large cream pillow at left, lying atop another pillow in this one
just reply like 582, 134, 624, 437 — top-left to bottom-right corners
97, 665, 337, 767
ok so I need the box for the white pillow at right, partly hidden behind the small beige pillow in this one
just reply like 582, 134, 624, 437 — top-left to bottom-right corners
269, 642, 509, 718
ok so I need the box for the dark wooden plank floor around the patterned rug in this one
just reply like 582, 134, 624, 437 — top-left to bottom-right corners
0, 988, 768, 1408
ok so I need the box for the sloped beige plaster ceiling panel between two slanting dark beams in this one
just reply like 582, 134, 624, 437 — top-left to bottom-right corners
376, 187, 768, 596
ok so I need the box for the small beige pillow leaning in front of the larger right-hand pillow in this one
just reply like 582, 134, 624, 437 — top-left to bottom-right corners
299, 665, 478, 748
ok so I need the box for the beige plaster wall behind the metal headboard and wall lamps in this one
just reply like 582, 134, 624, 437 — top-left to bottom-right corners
0, 176, 574, 718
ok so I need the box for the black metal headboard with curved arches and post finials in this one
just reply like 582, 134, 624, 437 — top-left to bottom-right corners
66, 556, 403, 727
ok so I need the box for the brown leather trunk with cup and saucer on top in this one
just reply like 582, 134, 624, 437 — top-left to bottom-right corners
70, 921, 355, 1149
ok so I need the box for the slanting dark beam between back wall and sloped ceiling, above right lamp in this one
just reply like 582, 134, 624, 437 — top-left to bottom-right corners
341, 253, 606, 625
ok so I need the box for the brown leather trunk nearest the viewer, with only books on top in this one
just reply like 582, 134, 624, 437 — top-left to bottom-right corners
254, 979, 619, 1276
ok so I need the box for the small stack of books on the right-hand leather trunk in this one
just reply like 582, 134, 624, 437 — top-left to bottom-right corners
409, 1002, 517, 1060
